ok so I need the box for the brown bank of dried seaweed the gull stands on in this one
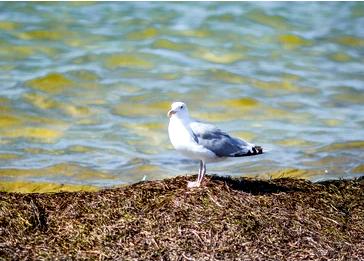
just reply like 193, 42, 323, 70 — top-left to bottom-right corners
0, 176, 364, 260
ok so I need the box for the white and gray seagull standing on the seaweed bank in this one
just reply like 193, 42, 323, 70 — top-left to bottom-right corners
167, 102, 263, 188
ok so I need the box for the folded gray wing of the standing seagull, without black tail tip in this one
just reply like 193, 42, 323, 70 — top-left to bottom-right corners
190, 122, 254, 157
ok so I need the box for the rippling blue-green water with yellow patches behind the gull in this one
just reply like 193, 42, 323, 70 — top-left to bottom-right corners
0, 2, 364, 190
